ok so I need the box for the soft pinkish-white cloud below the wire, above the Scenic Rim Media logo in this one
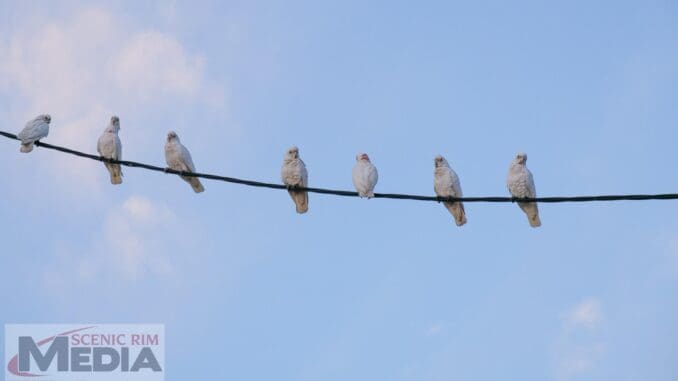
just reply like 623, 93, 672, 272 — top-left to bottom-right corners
44, 196, 194, 290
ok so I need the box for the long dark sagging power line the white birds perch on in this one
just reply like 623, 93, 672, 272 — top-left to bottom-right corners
0, 131, 678, 203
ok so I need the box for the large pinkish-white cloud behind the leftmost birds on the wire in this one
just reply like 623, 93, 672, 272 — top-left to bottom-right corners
0, 8, 224, 196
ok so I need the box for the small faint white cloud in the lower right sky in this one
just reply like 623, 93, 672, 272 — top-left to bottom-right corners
554, 298, 605, 380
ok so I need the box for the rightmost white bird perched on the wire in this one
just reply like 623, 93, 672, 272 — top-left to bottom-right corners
506, 152, 541, 228
